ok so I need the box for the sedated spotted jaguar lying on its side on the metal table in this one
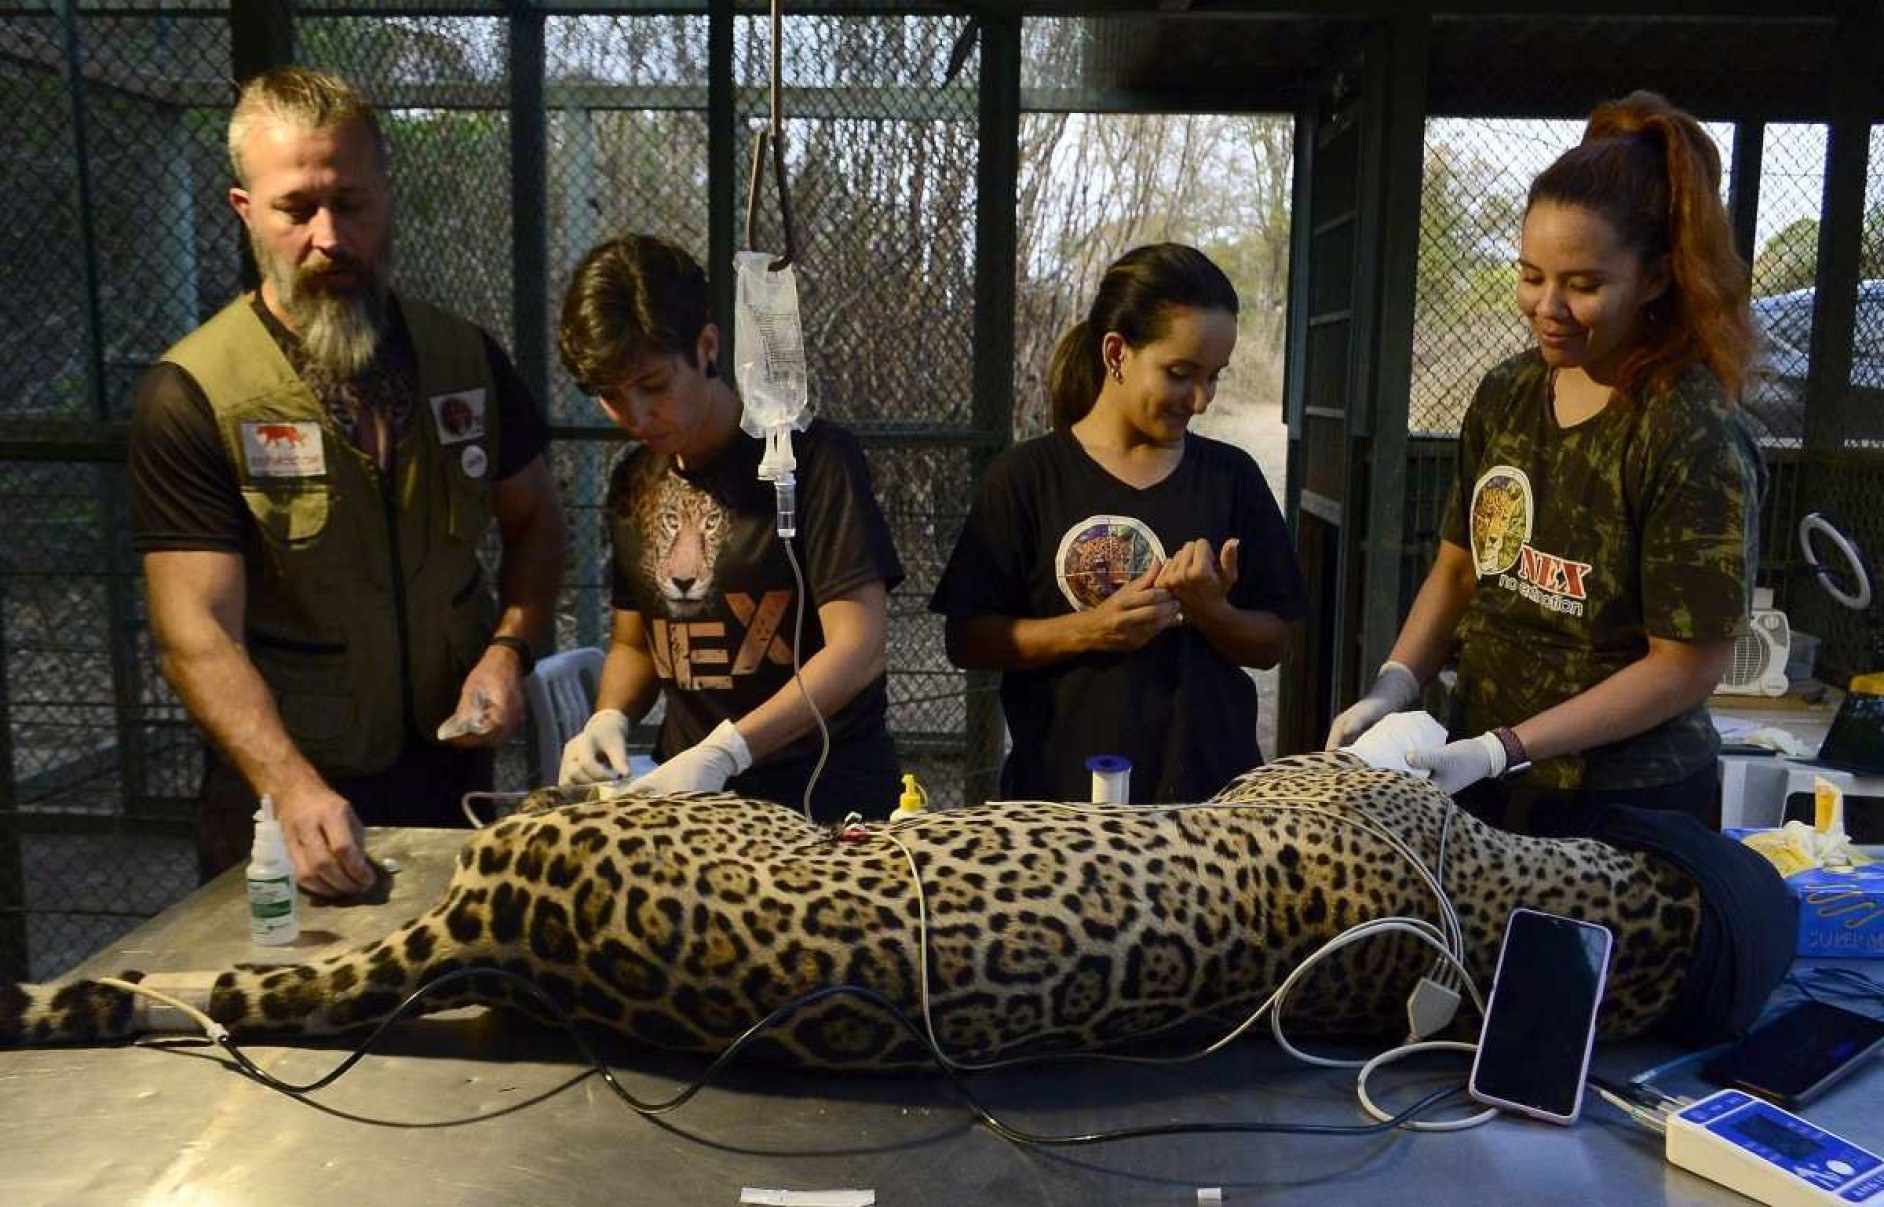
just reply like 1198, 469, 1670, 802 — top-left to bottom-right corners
0, 751, 1790, 1068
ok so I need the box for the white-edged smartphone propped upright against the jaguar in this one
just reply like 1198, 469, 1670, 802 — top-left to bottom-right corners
1468, 908, 1615, 1124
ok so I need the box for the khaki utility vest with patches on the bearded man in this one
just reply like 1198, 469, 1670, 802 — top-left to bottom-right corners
164, 296, 497, 778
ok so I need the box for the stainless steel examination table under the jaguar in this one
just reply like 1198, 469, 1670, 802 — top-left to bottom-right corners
0, 830, 1884, 1207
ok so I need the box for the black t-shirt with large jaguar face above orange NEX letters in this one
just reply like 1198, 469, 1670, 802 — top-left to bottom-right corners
607, 420, 902, 794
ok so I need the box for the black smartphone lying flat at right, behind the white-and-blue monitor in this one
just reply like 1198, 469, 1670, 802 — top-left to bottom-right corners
1701, 1002, 1884, 1107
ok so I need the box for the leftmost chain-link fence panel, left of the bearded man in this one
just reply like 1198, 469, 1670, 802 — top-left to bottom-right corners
0, 4, 239, 972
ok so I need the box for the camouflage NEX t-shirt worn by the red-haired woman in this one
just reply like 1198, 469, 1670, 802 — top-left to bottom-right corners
1443, 350, 1763, 789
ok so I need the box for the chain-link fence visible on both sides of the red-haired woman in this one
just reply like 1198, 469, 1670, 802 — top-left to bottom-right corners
1400, 98, 1884, 682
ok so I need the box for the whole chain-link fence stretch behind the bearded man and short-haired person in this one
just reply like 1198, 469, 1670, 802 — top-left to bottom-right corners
0, 4, 1004, 975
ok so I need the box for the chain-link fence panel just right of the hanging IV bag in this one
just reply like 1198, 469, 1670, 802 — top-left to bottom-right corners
733, 17, 980, 804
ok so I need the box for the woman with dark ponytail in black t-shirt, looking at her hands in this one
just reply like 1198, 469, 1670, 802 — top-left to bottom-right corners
929, 243, 1304, 802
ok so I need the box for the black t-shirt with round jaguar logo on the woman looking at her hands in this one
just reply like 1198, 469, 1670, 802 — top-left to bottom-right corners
929, 431, 1306, 802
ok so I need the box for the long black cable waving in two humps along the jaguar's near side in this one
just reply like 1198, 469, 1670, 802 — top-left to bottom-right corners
217, 968, 1466, 1147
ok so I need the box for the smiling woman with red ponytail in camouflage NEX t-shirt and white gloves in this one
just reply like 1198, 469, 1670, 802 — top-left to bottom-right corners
1328, 92, 1762, 834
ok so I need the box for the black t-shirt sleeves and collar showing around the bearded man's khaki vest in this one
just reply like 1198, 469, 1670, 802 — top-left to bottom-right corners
126, 298, 550, 554
